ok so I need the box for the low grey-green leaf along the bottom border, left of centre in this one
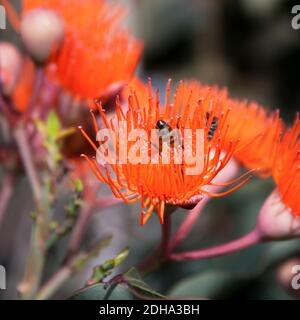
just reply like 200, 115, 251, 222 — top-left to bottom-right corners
69, 283, 134, 300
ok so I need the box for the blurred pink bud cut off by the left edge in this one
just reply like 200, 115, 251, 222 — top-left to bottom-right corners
0, 42, 22, 95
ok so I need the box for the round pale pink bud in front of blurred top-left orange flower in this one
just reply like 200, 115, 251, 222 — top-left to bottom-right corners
21, 8, 64, 63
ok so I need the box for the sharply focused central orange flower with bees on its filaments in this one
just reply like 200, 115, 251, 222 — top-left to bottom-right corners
79, 81, 250, 225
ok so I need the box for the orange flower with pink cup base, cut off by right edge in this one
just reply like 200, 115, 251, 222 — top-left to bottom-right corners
257, 114, 300, 240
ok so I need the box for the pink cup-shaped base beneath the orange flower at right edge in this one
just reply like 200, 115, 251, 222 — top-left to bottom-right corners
256, 190, 300, 240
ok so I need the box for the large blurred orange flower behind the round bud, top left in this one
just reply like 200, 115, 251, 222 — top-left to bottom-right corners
22, 0, 142, 100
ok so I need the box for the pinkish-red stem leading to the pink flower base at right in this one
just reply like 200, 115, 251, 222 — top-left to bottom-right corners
169, 228, 263, 261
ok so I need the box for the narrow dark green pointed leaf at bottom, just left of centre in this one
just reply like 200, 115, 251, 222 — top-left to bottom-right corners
124, 268, 167, 299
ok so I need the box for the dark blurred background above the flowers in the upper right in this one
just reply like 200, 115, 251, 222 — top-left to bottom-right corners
137, 0, 300, 121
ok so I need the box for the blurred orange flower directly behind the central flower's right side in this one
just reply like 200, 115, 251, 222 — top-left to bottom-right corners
179, 81, 284, 177
